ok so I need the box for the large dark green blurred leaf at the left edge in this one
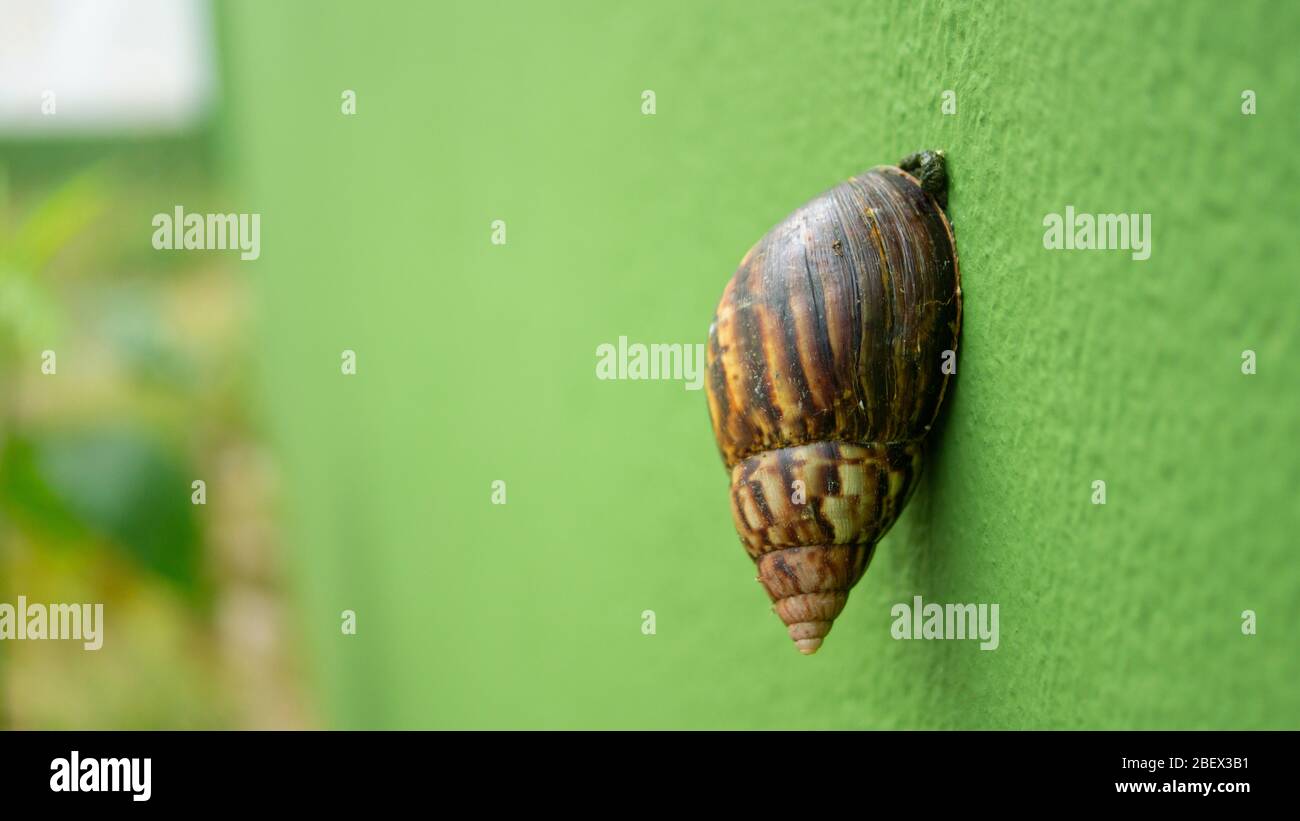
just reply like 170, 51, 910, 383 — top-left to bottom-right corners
0, 427, 200, 595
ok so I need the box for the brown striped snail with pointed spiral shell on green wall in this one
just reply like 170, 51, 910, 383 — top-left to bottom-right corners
705, 151, 962, 655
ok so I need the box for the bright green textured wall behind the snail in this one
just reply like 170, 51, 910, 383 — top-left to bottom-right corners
226, 0, 1300, 727
